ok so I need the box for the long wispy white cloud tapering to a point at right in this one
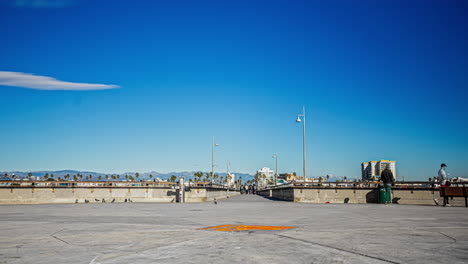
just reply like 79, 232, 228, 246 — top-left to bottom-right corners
0, 71, 120, 91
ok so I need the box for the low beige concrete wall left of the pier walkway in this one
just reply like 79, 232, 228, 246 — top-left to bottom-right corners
0, 187, 239, 204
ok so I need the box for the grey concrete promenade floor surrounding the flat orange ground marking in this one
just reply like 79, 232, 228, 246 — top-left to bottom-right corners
0, 196, 468, 264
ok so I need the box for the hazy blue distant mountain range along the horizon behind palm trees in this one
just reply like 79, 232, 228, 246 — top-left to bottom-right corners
0, 170, 254, 182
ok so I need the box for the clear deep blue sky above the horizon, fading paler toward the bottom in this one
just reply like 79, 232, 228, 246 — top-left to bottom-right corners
0, 0, 468, 180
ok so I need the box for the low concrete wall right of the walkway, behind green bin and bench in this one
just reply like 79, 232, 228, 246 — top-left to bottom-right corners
257, 186, 464, 206
